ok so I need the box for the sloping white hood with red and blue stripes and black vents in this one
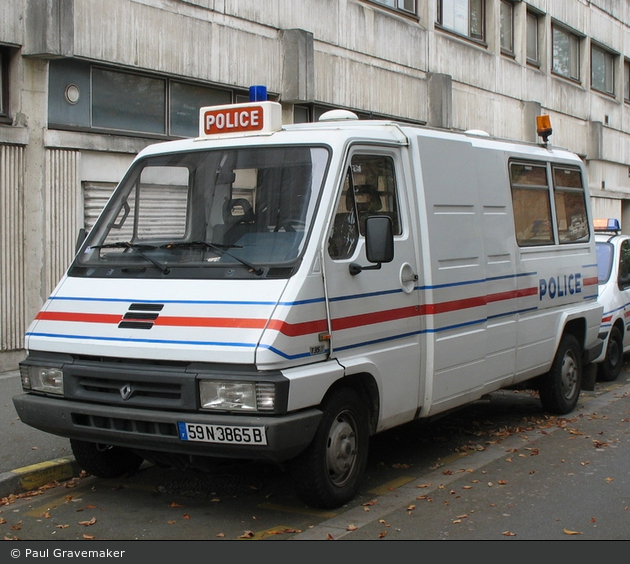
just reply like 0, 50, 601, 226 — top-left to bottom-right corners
26, 277, 288, 364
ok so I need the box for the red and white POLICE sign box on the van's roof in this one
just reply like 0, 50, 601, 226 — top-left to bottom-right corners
199, 102, 282, 139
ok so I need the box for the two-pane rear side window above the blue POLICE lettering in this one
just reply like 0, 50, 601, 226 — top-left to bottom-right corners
510, 162, 589, 247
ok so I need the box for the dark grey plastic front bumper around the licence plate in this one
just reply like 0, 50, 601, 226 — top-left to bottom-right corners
13, 393, 322, 462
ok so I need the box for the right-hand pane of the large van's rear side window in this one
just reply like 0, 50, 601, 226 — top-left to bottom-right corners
553, 166, 589, 243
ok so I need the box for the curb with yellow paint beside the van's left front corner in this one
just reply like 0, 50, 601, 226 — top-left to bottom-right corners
0, 457, 81, 498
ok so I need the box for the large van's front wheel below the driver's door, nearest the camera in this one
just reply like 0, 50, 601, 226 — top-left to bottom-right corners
291, 388, 369, 509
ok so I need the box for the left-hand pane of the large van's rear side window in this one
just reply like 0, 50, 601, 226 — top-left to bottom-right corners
510, 163, 554, 247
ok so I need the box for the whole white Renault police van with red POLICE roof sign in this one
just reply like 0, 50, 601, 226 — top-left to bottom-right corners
14, 101, 602, 507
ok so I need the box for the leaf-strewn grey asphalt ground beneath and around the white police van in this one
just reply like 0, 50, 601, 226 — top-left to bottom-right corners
0, 367, 630, 540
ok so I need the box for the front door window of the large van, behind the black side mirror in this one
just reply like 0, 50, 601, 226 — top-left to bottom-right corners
328, 154, 402, 259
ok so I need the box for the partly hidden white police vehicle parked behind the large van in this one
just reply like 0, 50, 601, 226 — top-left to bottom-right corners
594, 218, 630, 382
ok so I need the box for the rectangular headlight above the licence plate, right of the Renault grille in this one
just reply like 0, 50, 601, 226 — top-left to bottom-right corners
199, 380, 276, 411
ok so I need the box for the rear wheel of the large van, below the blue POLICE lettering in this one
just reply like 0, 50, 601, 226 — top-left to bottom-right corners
539, 334, 582, 415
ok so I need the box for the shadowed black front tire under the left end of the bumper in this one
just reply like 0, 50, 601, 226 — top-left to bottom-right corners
70, 439, 144, 478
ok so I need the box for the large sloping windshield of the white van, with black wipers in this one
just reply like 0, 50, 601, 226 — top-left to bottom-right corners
70, 147, 328, 278
